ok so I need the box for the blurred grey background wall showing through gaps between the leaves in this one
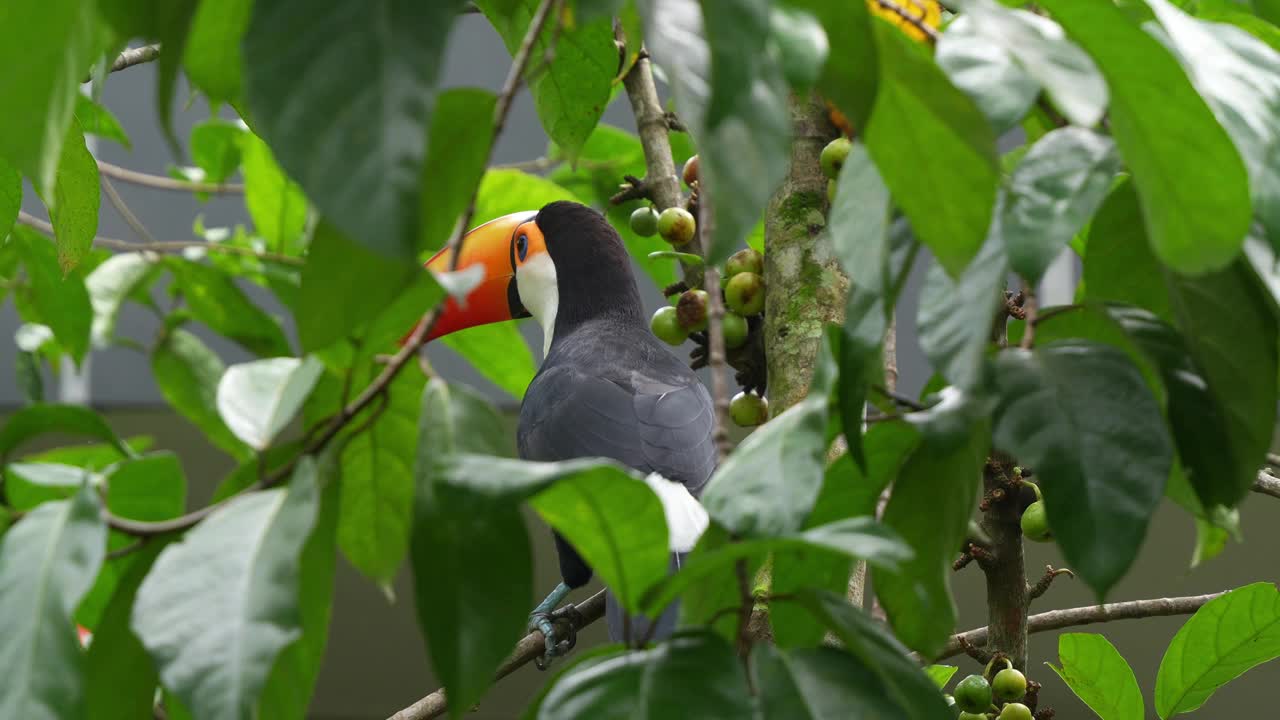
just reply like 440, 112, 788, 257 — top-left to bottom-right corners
0, 15, 1280, 720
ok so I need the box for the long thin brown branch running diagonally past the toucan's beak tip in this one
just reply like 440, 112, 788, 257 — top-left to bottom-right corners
104, 0, 556, 537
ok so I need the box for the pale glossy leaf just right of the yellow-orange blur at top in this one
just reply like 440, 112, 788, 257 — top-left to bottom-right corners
936, 13, 1044, 133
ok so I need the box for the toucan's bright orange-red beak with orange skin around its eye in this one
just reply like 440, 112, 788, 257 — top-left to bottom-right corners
426, 211, 545, 341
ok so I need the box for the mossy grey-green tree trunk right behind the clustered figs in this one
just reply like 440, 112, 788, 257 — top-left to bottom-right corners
764, 95, 849, 415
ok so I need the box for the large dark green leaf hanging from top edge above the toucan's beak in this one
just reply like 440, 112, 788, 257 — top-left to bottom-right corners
243, 0, 462, 259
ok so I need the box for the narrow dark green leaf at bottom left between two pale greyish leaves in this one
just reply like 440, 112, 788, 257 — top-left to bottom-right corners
84, 538, 169, 720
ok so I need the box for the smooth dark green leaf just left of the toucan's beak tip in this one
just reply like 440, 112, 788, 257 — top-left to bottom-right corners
294, 218, 419, 351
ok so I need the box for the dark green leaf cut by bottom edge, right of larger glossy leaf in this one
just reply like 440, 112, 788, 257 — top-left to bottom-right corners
751, 643, 902, 720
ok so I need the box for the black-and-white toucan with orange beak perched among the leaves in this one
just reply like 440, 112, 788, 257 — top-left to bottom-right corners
426, 201, 717, 660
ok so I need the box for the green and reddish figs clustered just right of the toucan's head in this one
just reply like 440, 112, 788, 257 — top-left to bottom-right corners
631, 155, 769, 427
